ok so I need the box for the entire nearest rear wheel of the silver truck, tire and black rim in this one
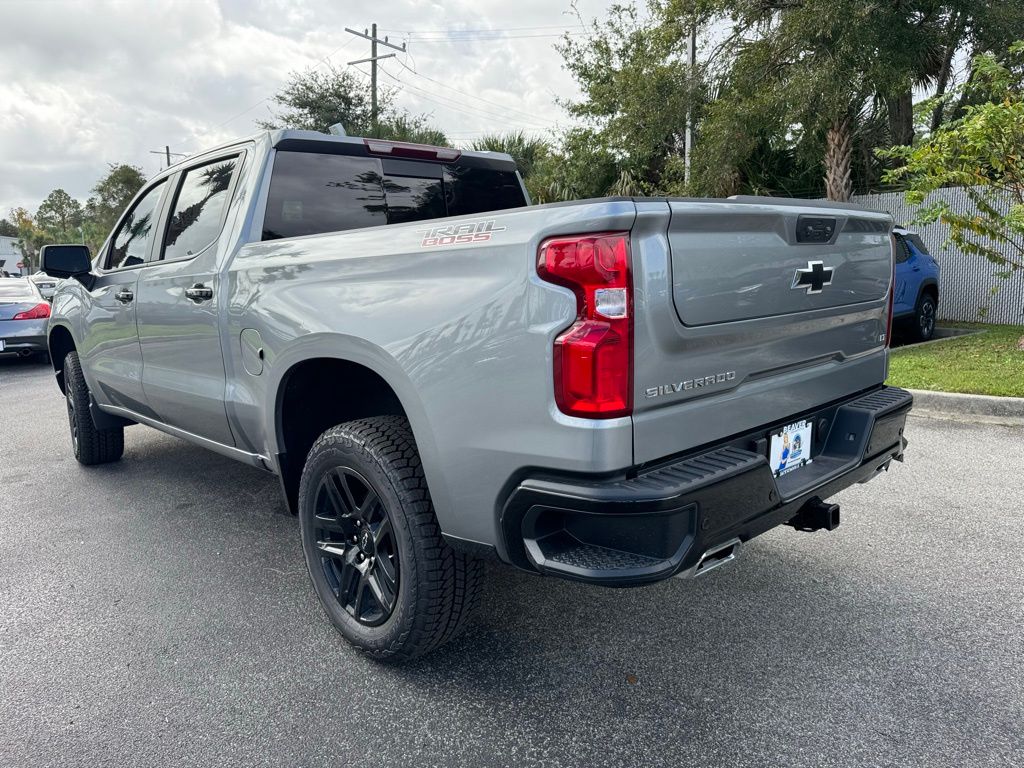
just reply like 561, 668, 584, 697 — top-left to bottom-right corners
299, 416, 482, 660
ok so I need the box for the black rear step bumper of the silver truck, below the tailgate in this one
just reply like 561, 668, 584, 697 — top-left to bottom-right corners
502, 387, 913, 587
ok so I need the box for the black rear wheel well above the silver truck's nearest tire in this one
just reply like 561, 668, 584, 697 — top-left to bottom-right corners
276, 357, 406, 514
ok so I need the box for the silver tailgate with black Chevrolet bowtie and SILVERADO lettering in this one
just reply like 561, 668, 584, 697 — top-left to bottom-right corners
632, 198, 892, 463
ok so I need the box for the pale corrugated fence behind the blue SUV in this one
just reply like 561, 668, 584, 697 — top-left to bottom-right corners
853, 187, 1024, 325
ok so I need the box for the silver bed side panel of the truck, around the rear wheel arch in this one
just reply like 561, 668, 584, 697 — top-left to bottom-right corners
225, 201, 635, 544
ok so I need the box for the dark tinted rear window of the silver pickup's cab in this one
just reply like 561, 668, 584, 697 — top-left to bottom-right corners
263, 151, 526, 240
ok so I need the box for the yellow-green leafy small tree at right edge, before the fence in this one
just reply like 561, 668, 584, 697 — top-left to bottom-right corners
881, 41, 1024, 276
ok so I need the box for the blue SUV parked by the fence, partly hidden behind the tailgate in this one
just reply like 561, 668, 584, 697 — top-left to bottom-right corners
893, 226, 939, 341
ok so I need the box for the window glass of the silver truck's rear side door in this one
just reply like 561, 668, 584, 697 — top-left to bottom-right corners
164, 158, 239, 259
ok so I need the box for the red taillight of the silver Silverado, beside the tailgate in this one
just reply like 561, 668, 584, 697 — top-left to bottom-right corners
537, 232, 633, 419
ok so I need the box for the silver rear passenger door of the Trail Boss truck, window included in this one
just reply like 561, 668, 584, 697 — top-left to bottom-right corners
137, 157, 239, 445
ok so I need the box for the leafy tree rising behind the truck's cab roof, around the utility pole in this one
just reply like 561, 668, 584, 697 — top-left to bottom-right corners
256, 66, 447, 144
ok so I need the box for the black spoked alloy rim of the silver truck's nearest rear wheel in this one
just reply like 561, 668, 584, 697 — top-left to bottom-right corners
313, 467, 400, 627
